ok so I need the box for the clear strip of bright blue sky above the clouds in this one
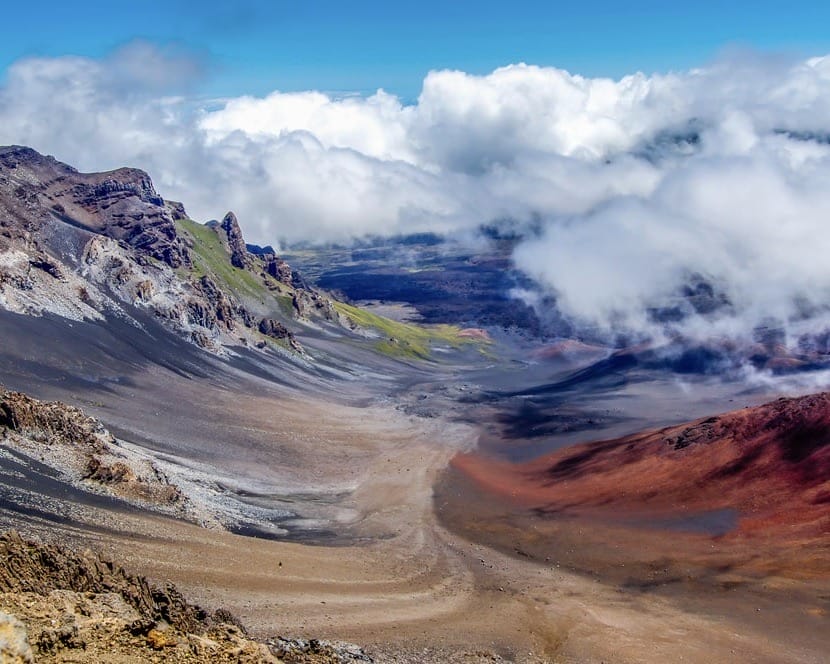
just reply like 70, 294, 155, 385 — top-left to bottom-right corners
0, 0, 830, 100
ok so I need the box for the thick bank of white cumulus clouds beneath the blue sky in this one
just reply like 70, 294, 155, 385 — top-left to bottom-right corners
0, 44, 830, 342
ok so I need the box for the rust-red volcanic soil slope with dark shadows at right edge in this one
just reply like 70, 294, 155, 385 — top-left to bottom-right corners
453, 393, 830, 544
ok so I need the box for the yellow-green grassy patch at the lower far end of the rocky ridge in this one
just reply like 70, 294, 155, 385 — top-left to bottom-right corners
334, 302, 481, 360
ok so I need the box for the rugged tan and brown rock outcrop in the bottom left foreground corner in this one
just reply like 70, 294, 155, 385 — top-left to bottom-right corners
0, 531, 372, 664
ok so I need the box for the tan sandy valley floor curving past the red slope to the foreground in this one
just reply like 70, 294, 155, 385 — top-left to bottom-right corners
4, 360, 830, 662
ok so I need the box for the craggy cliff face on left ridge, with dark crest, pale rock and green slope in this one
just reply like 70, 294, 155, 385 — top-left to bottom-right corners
0, 146, 337, 353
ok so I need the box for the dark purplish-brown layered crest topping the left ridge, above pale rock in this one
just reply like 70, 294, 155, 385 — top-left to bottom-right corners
0, 146, 191, 268
